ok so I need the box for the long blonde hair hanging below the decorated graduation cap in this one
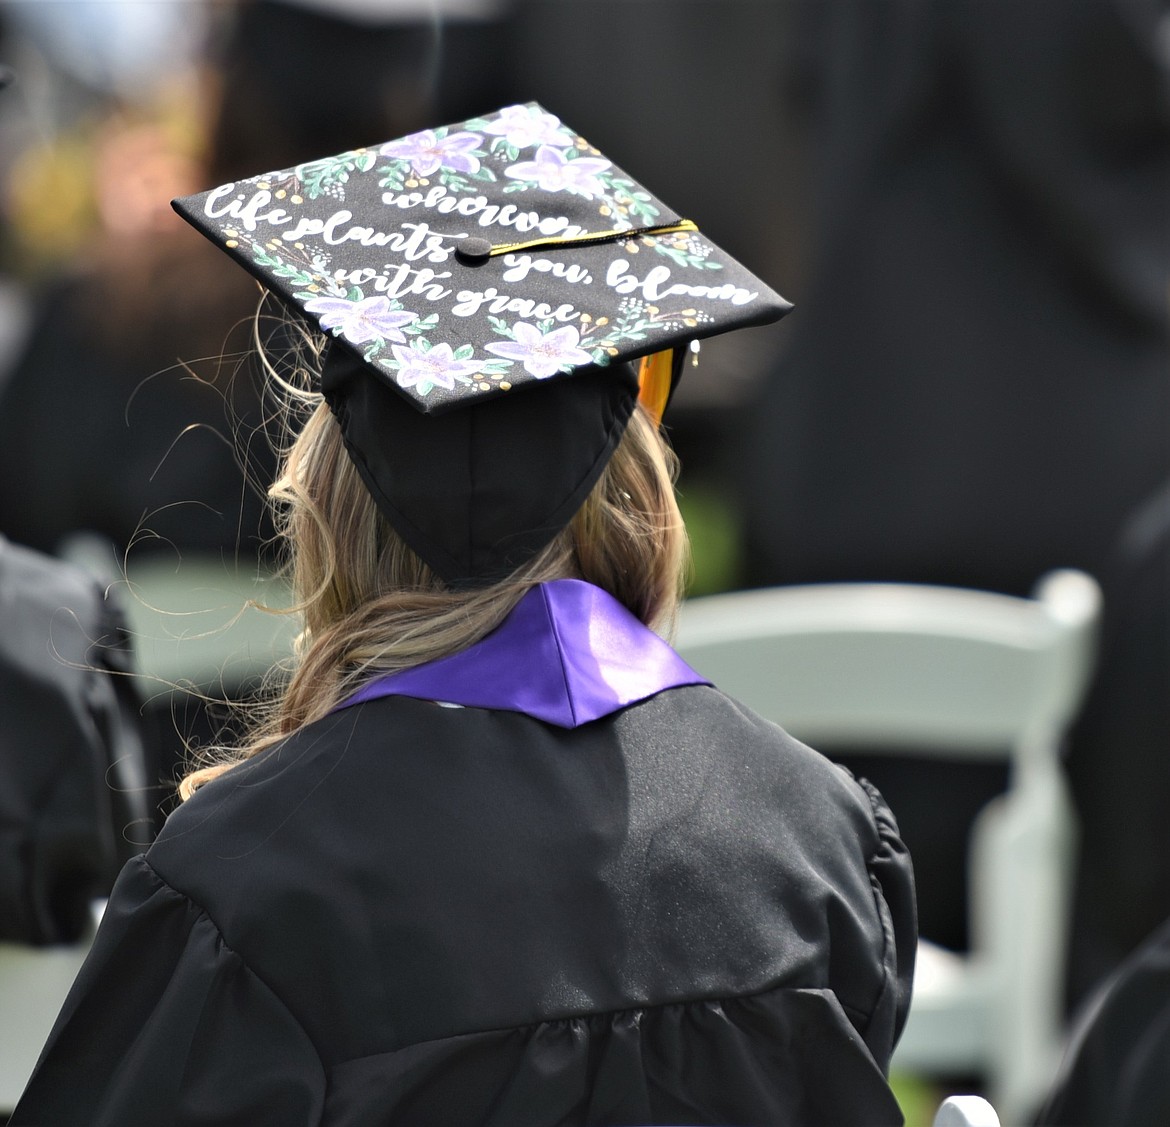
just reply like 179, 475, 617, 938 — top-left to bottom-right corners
179, 388, 689, 799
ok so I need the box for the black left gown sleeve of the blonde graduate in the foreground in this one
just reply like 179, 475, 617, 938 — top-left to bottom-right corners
9, 857, 325, 1127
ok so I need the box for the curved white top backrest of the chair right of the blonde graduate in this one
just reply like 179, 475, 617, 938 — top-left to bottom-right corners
675, 570, 1100, 757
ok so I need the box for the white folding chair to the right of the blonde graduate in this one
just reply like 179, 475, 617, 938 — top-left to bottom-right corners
676, 571, 1101, 1122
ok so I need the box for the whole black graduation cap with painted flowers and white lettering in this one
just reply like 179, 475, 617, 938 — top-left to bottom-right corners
174, 103, 791, 585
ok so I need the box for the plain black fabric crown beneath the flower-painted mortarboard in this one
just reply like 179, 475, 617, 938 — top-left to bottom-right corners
322, 344, 638, 586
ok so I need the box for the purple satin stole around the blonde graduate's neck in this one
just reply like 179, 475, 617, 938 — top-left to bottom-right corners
339, 579, 710, 728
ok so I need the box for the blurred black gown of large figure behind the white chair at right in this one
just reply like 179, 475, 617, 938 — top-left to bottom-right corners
737, 0, 1170, 959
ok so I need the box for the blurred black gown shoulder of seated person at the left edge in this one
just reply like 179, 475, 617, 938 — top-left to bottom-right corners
0, 536, 158, 943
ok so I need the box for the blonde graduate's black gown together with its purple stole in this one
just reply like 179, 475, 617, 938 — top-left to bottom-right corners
12, 580, 915, 1127
